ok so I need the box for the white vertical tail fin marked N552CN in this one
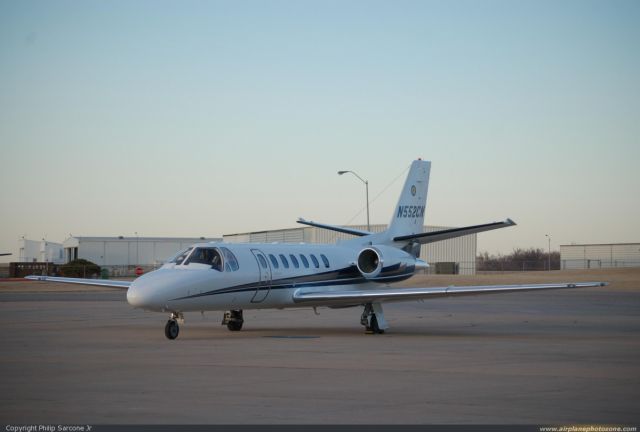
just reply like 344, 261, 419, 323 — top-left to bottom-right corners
386, 160, 431, 238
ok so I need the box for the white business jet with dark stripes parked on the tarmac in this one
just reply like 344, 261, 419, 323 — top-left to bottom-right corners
27, 160, 605, 339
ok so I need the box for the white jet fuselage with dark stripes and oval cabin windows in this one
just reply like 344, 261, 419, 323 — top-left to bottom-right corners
127, 243, 416, 312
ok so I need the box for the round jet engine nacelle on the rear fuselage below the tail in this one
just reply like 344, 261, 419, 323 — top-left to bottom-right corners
356, 246, 416, 279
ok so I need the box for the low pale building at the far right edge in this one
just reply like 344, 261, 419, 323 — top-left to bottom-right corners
560, 243, 640, 270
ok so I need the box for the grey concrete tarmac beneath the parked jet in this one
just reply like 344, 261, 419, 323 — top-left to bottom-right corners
0, 272, 640, 426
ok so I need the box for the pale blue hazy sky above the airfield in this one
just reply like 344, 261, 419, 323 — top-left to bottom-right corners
0, 0, 640, 261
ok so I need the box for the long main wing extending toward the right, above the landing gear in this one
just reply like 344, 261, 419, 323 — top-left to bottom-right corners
293, 282, 607, 306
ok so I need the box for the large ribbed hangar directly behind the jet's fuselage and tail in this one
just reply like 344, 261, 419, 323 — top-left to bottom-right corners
223, 224, 477, 275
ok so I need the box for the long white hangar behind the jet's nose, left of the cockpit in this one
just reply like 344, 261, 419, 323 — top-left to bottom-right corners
62, 236, 221, 266
